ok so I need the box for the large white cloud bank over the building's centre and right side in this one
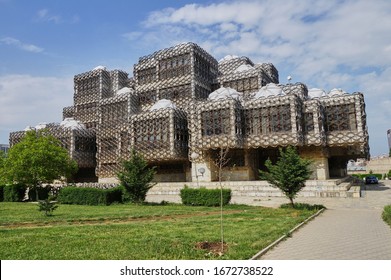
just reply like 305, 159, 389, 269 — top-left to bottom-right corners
123, 0, 391, 154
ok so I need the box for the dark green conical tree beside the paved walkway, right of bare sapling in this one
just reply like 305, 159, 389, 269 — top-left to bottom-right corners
259, 146, 312, 207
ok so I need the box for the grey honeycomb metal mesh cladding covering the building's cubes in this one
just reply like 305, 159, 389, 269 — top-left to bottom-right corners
10, 43, 369, 182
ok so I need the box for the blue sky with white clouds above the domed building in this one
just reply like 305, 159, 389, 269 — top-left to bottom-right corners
0, 0, 391, 157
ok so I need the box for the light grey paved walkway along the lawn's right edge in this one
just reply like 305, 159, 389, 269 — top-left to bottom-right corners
260, 181, 391, 260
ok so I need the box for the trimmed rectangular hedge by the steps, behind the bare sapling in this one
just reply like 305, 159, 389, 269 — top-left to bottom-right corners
181, 186, 231, 206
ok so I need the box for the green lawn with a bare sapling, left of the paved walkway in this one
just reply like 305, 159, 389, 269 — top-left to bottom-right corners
0, 202, 316, 260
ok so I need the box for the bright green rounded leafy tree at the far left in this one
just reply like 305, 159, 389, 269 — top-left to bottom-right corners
3, 130, 77, 200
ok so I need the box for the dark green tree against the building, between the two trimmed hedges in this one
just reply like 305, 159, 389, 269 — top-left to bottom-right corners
117, 150, 156, 203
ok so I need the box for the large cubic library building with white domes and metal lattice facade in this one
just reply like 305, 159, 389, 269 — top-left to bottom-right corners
10, 43, 369, 183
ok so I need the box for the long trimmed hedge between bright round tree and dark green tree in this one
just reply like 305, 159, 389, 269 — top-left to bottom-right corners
58, 187, 122, 205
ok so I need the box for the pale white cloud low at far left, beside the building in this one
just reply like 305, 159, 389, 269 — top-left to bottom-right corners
0, 75, 73, 143
